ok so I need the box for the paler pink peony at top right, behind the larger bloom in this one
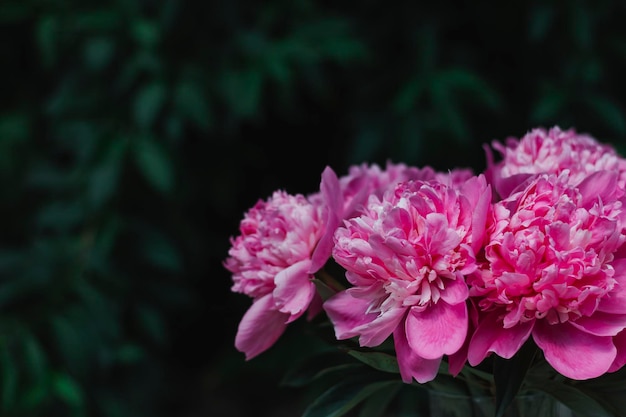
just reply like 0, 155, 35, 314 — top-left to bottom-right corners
485, 127, 626, 197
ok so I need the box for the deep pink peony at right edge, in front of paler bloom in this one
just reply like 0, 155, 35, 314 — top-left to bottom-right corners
467, 170, 626, 380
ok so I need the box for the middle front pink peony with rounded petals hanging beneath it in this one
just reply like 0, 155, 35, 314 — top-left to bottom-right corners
323, 175, 491, 383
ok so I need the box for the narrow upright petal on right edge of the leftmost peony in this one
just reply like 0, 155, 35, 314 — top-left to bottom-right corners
309, 167, 343, 274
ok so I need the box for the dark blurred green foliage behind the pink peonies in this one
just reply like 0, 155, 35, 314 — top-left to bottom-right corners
0, 0, 626, 417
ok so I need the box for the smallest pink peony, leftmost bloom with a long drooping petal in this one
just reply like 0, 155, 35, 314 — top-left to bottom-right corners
224, 191, 324, 360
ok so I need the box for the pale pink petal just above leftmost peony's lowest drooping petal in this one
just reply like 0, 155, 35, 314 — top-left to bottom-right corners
273, 259, 315, 322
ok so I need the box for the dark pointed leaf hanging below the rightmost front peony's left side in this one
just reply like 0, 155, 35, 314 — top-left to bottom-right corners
493, 340, 538, 417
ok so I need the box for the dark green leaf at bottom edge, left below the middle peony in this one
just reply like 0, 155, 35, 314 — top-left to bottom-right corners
302, 380, 398, 417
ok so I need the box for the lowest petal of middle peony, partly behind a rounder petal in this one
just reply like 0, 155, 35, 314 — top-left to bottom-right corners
393, 326, 441, 384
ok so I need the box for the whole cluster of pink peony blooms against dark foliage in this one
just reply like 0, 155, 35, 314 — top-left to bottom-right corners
224, 127, 626, 414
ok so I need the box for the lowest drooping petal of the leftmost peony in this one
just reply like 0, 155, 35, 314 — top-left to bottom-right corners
235, 294, 289, 360
